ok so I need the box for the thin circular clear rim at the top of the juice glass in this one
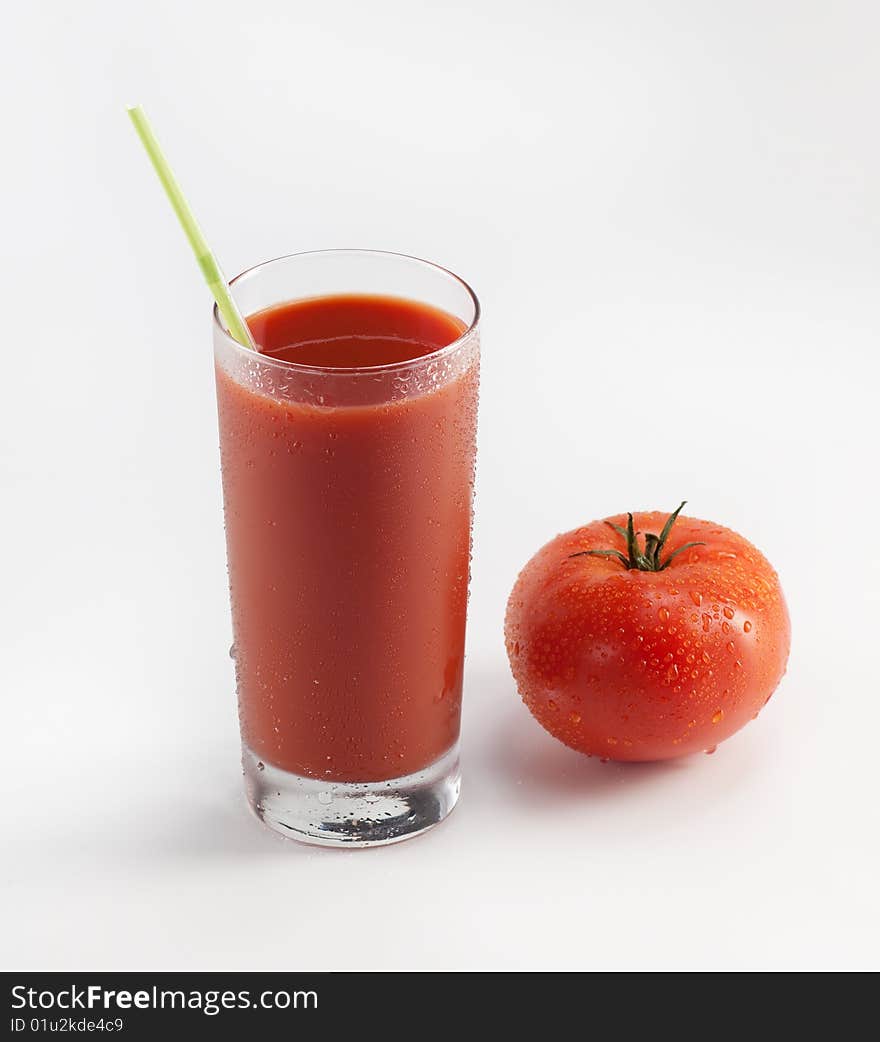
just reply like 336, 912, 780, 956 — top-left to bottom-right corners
212, 248, 480, 375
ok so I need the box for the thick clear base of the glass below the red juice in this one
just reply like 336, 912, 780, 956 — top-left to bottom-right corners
242, 742, 461, 847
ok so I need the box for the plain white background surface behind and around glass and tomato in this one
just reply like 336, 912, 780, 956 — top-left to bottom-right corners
0, 0, 880, 970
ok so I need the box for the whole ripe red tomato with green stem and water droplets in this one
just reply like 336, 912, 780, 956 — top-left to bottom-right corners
504, 503, 790, 760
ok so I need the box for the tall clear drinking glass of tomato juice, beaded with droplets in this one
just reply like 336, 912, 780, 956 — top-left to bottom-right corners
213, 250, 479, 846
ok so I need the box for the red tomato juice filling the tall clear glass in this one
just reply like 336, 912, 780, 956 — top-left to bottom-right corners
217, 296, 478, 780
